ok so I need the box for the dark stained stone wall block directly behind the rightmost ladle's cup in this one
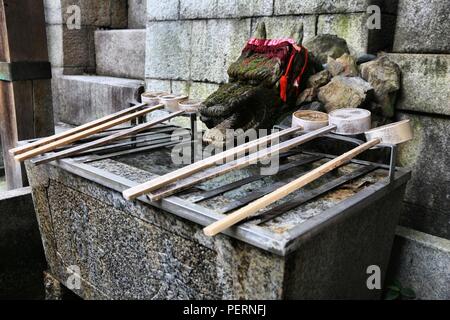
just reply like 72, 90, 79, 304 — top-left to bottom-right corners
399, 113, 450, 239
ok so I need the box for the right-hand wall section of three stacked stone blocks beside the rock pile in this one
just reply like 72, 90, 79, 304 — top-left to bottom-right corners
389, 0, 450, 239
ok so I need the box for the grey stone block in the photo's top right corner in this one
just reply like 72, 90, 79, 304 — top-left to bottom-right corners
394, 0, 450, 53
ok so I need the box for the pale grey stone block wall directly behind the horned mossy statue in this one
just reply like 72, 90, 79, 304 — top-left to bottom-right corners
145, 0, 396, 98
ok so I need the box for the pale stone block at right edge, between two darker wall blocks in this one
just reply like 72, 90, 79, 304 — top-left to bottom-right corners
388, 54, 450, 115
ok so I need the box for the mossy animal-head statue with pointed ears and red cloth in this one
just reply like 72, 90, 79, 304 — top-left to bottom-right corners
200, 23, 314, 143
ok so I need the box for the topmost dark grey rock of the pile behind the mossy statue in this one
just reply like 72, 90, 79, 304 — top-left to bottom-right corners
305, 34, 350, 64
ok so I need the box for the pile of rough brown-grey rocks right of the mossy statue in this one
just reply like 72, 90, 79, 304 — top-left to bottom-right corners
297, 35, 401, 126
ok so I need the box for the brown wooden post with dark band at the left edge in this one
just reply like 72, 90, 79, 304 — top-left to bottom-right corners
0, 0, 54, 189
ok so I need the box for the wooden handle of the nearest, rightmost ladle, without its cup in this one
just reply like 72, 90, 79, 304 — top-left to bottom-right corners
203, 139, 381, 236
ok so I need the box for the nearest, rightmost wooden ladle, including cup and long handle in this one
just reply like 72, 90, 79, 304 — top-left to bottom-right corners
203, 120, 413, 236
